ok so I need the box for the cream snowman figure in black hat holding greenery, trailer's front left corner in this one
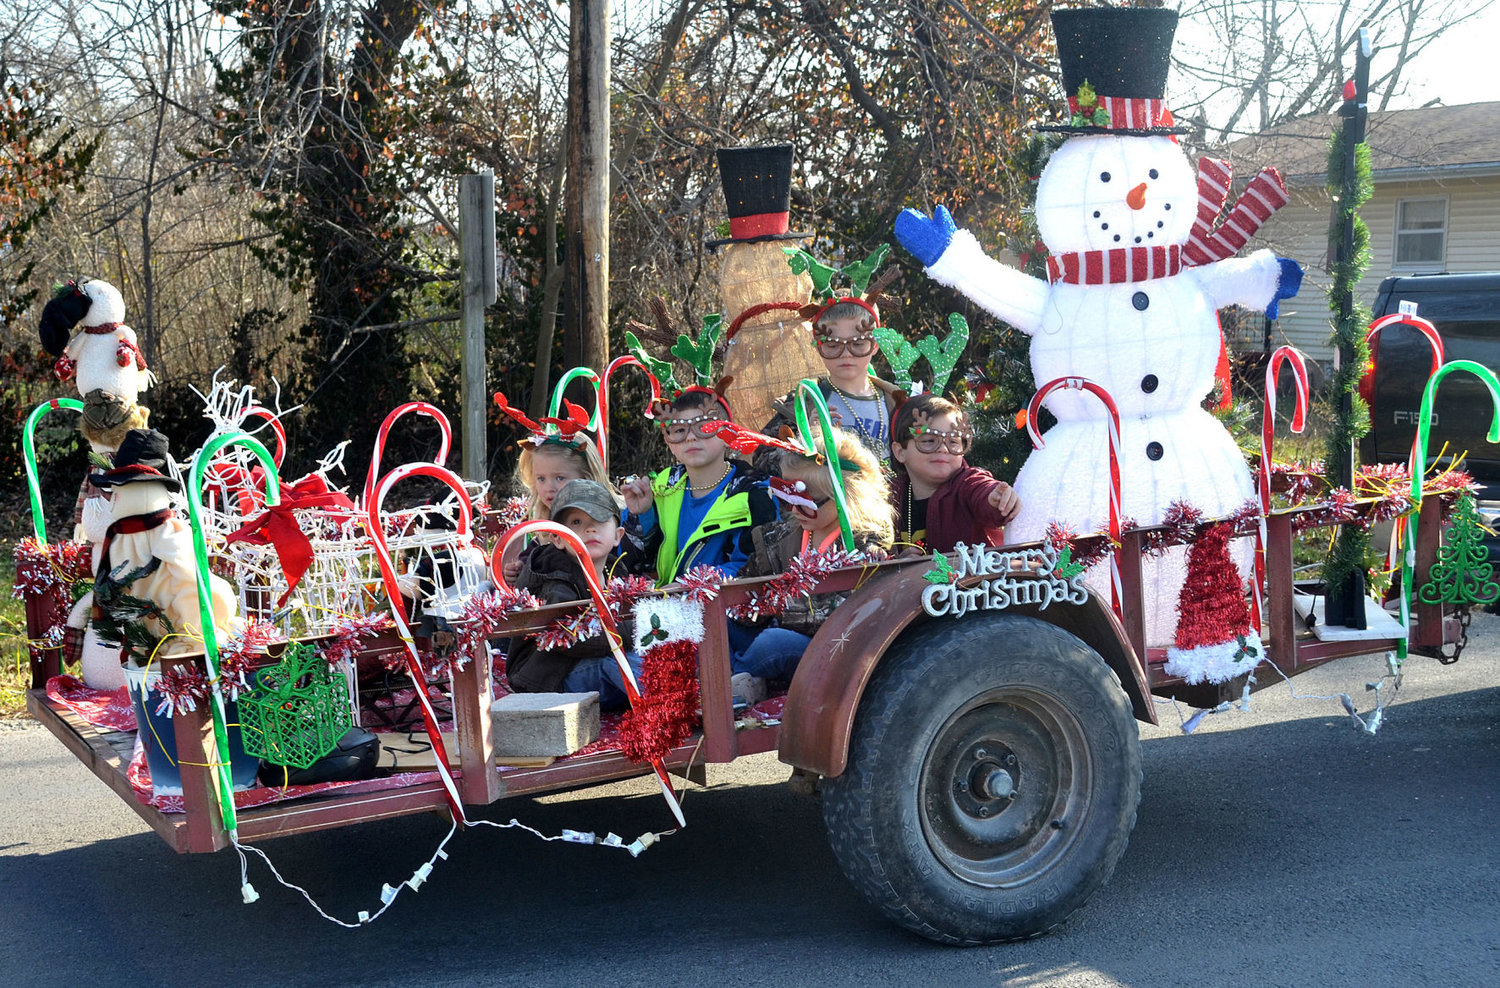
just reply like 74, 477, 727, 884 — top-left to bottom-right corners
68, 429, 236, 688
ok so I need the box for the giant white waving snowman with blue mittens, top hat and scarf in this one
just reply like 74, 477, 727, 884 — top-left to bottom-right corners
896, 7, 1302, 645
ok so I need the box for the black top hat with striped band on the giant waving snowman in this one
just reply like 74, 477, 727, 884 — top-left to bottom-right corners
1038, 7, 1187, 135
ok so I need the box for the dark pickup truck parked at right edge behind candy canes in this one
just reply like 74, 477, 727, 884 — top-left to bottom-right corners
1361, 273, 1500, 488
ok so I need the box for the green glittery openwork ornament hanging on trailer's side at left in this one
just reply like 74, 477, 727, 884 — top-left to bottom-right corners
240, 642, 351, 769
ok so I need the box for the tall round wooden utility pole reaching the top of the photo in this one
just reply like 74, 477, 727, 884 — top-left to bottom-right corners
563, 0, 609, 370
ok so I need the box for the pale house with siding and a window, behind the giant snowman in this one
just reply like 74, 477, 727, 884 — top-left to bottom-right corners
1224, 102, 1500, 361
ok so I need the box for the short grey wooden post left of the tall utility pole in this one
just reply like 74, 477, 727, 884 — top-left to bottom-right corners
459, 171, 500, 480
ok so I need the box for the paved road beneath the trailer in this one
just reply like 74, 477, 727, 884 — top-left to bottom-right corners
0, 616, 1500, 988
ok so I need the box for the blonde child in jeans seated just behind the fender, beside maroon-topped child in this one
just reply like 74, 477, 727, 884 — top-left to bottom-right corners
731, 430, 894, 703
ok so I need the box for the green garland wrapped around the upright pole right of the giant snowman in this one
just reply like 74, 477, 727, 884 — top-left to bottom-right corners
1323, 121, 1374, 602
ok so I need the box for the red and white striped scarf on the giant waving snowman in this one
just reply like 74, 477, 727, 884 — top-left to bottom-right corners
1047, 157, 1289, 285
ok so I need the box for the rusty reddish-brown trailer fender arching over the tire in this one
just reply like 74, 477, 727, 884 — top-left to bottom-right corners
779, 567, 1157, 777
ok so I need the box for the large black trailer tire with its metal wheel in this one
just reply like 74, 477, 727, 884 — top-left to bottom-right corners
824, 615, 1142, 945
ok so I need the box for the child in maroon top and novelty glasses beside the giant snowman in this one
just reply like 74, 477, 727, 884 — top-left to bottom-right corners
891, 393, 1022, 555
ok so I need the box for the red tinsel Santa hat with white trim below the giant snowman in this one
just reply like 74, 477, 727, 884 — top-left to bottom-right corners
1166, 522, 1266, 685
